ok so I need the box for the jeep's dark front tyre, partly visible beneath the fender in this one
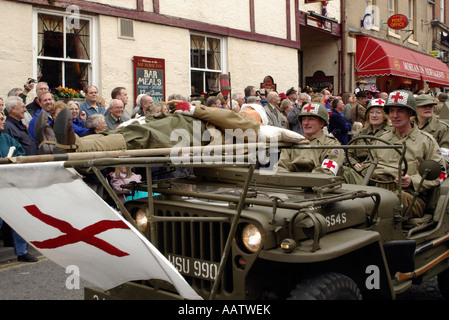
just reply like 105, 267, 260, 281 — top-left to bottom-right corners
289, 272, 362, 300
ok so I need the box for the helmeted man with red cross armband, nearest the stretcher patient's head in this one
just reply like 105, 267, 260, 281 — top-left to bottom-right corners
278, 102, 343, 175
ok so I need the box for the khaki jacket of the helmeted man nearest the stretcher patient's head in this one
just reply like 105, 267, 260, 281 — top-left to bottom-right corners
278, 133, 344, 174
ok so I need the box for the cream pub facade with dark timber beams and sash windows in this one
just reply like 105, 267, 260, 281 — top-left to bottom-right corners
0, 0, 343, 112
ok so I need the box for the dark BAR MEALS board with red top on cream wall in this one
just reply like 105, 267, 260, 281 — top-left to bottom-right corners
133, 56, 165, 102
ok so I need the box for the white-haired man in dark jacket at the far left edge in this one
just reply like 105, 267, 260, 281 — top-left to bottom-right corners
3, 96, 37, 156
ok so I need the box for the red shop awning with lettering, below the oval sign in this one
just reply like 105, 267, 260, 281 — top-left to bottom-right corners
356, 36, 449, 87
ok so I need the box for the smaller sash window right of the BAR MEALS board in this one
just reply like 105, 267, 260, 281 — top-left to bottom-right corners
190, 34, 223, 93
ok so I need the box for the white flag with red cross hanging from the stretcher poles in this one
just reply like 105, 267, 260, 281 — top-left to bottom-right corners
0, 162, 201, 299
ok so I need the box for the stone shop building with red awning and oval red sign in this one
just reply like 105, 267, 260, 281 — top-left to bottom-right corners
344, 0, 449, 92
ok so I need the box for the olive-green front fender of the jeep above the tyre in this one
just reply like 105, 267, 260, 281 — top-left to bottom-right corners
259, 229, 395, 299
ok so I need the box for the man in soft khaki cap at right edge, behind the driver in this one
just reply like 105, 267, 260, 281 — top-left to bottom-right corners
415, 94, 449, 148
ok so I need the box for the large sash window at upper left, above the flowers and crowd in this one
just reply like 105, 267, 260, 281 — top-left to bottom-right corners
37, 13, 92, 90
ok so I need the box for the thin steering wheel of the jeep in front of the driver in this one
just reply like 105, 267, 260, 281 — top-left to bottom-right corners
345, 135, 408, 184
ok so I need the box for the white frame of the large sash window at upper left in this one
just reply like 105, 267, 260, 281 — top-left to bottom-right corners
33, 8, 99, 87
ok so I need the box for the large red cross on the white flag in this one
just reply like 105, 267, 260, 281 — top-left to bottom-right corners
24, 205, 129, 257
